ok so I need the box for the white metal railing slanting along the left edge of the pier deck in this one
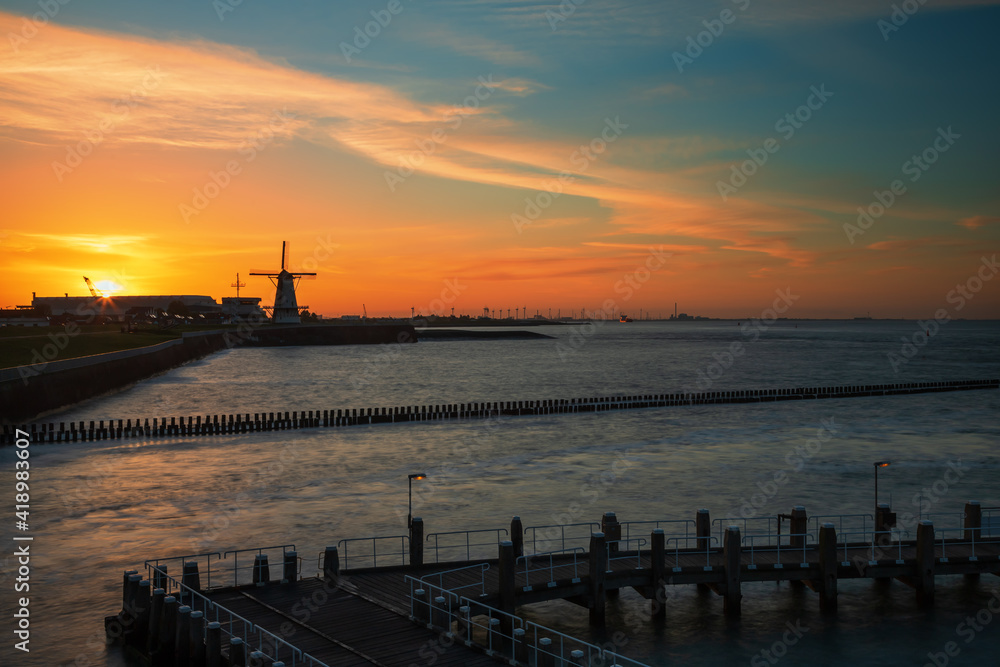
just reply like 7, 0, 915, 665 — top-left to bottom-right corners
145, 564, 329, 667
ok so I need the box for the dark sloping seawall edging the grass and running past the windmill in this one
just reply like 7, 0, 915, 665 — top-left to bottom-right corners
0, 324, 416, 426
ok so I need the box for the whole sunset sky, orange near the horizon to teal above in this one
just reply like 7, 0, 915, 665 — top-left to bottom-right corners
0, 0, 1000, 319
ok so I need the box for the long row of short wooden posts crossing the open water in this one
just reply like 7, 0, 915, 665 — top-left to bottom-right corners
0, 380, 1000, 445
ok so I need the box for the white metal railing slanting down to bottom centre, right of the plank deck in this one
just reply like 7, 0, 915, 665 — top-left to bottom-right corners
406, 576, 647, 667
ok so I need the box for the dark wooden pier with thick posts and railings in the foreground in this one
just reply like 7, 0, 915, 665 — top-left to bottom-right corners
105, 501, 1000, 667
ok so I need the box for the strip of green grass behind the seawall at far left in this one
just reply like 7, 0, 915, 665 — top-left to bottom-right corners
0, 324, 225, 368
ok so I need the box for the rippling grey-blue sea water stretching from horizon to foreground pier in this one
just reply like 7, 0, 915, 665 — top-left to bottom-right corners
0, 320, 1000, 667
